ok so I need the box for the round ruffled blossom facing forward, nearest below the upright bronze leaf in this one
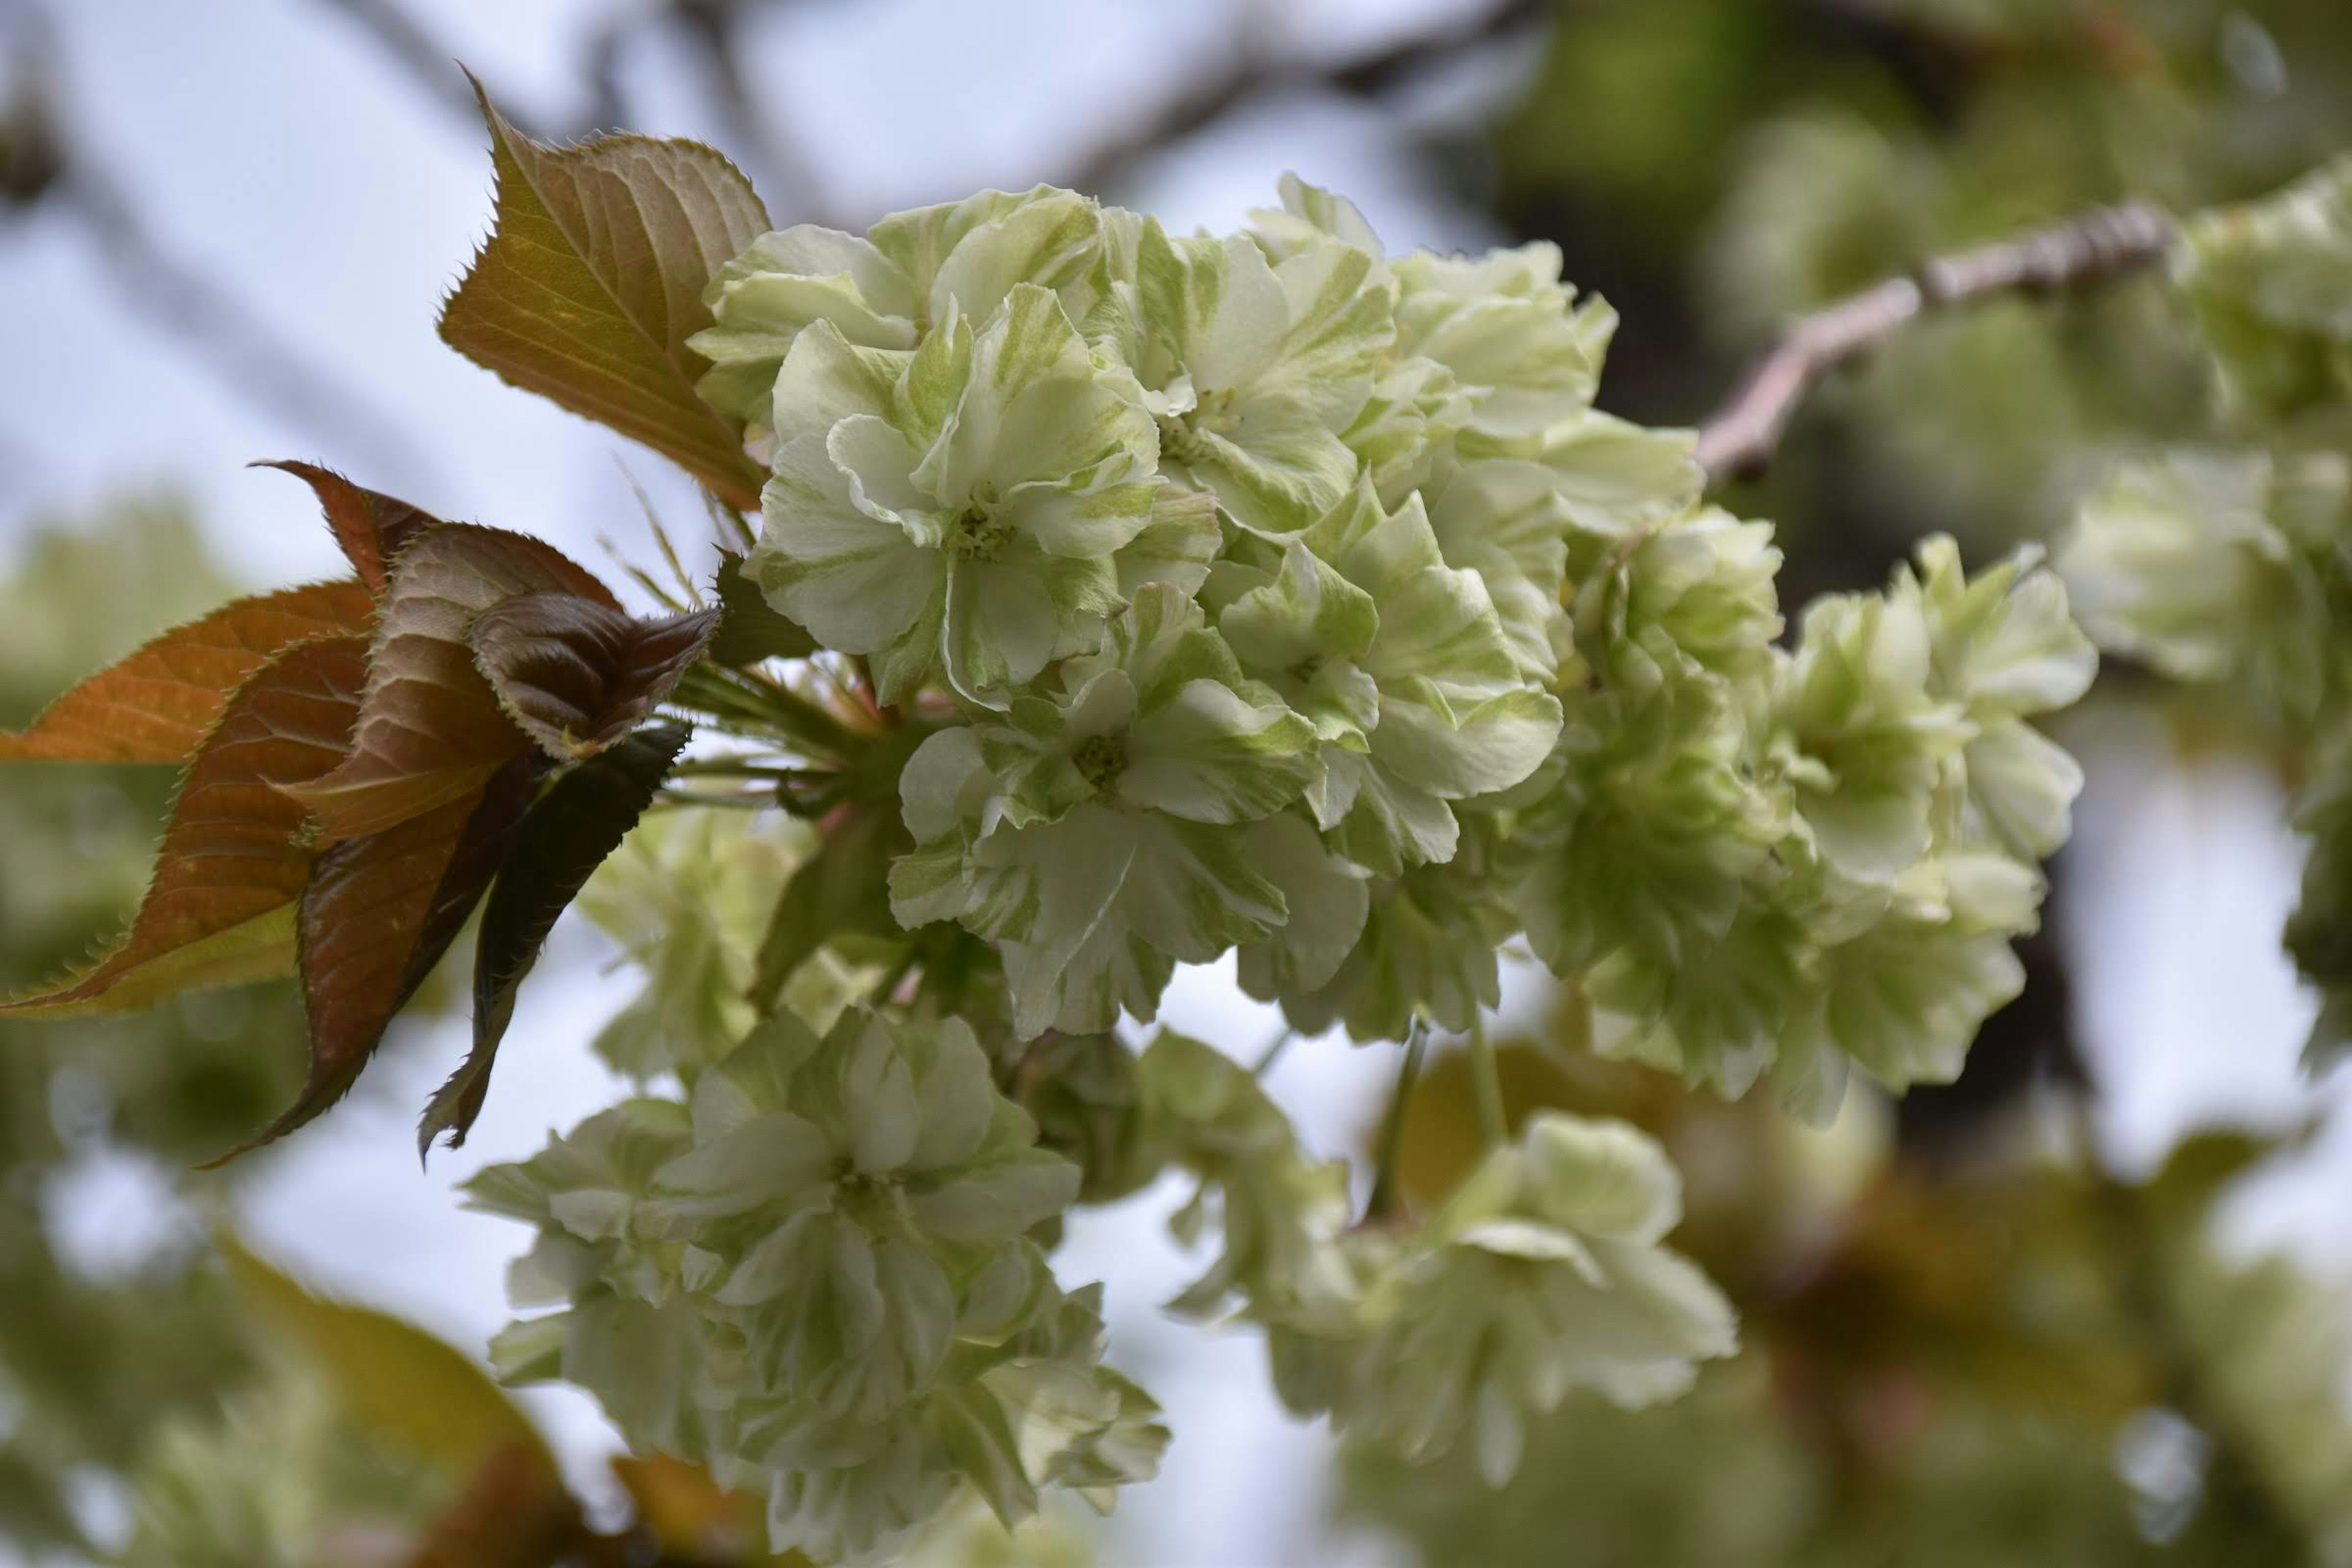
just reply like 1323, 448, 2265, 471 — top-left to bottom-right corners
753, 282, 1159, 705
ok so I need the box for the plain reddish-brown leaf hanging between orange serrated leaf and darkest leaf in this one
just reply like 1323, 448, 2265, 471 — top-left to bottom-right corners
214, 750, 538, 1166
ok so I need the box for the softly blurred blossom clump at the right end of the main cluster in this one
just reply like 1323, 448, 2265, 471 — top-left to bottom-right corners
1517, 536, 2095, 1117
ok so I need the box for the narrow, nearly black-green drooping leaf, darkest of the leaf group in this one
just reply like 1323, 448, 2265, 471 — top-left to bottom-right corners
417, 724, 689, 1154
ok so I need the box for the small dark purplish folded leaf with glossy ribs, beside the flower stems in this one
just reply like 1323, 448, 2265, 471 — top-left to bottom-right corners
470, 592, 720, 762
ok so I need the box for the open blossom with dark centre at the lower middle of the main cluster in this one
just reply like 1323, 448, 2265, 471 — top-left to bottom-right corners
891, 583, 1362, 1037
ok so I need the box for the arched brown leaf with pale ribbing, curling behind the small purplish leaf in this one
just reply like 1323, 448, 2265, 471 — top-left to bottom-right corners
289, 522, 619, 839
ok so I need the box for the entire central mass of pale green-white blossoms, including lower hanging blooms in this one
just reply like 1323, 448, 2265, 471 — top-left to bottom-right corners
475, 179, 2117, 1561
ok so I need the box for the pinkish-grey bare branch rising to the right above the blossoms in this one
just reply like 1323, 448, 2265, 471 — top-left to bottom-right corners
1696, 202, 2178, 480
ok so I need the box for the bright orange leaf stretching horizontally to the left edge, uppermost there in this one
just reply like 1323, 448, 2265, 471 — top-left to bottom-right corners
0, 583, 376, 762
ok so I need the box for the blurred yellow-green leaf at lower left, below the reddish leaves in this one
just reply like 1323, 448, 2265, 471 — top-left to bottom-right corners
221, 1239, 557, 1479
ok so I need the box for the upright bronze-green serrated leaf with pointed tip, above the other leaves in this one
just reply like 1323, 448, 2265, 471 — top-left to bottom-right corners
440, 82, 769, 510
